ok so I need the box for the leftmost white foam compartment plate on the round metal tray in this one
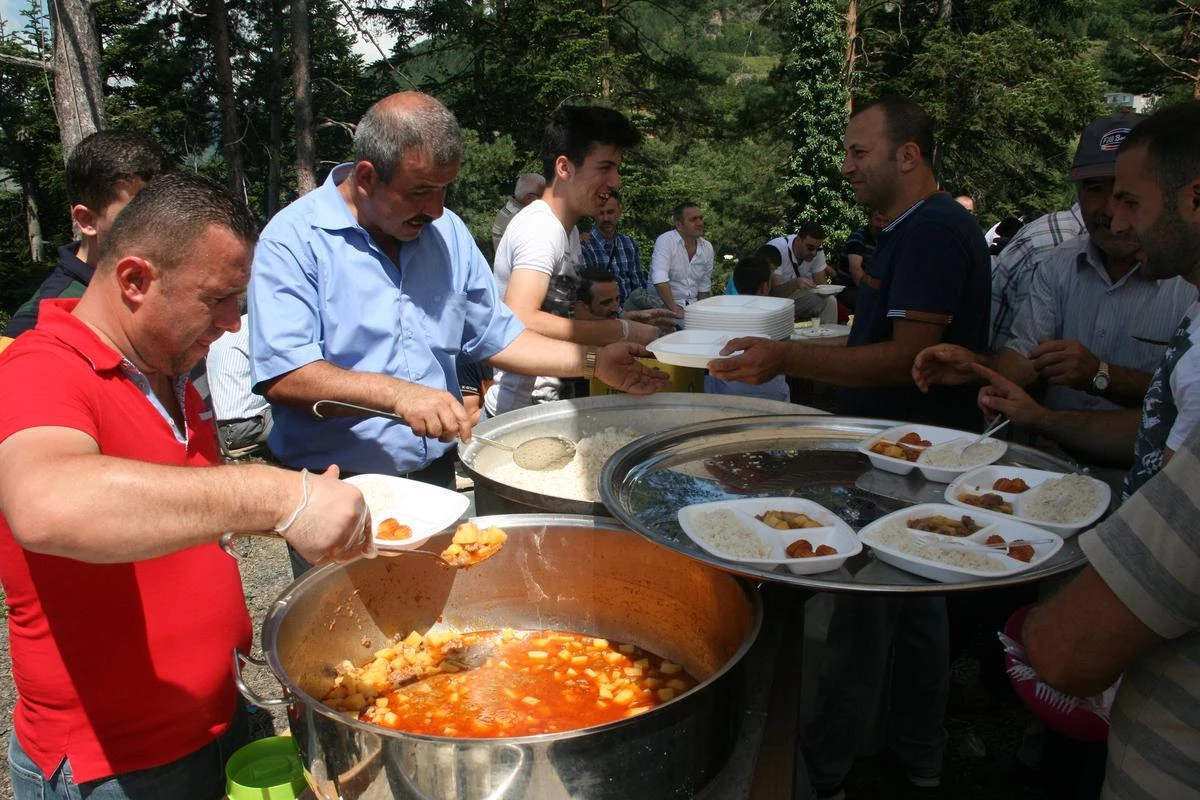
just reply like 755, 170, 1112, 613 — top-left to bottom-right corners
678, 497, 863, 575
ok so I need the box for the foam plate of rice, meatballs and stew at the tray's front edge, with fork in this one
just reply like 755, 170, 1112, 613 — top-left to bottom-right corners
858, 503, 1062, 583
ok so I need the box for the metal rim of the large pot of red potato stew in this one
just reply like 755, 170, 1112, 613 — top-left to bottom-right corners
262, 513, 762, 745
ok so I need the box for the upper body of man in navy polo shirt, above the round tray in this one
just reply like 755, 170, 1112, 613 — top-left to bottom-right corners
709, 97, 991, 428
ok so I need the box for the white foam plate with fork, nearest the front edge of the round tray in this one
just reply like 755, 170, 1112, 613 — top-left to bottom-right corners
858, 503, 1062, 583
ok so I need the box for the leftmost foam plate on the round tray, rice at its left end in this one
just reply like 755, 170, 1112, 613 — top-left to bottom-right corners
678, 497, 863, 575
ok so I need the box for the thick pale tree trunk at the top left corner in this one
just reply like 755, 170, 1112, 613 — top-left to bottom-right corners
49, 0, 104, 160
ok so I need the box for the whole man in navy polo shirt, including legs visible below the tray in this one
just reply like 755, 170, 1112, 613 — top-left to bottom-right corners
709, 97, 991, 799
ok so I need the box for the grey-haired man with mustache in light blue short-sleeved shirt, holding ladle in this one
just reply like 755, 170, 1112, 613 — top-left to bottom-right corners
250, 92, 666, 485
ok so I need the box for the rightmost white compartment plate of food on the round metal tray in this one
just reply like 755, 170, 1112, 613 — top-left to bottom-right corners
946, 464, 1112, 539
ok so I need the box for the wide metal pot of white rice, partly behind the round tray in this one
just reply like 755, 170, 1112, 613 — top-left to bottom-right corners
458, 392, 824, 516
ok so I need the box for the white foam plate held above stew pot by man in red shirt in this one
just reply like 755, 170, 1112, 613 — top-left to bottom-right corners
346, 474, 470, 551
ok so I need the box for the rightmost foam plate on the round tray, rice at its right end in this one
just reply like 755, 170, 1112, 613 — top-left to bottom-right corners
946, 464, 1112, 539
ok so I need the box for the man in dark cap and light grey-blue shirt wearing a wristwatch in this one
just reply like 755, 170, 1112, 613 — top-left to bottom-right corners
914, 114, 1196, 424
